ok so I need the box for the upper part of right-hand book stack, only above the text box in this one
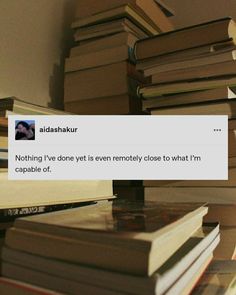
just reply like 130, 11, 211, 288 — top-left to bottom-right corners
135, 18, 236, 118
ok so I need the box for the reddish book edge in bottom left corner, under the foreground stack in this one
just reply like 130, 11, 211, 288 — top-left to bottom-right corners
0, 277, 62, 295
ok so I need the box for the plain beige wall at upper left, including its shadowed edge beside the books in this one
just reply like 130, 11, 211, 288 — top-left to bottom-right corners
0, 0, 75, 108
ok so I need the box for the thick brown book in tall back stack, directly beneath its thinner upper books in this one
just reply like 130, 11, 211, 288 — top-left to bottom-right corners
70, 32, 137, 58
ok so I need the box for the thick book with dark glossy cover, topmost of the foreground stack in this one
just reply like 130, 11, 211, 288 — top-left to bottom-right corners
6, 201, 207, 276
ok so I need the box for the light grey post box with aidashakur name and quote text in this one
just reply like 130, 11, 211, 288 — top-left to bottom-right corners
8, 115, 228, 181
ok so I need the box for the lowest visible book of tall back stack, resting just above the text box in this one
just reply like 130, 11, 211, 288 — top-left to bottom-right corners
65, 94, 142, 115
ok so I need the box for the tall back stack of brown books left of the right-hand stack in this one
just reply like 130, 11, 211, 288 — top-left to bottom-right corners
64, 0, 172, 115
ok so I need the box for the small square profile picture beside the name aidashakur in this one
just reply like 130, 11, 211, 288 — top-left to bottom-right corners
15, 120, 35, 140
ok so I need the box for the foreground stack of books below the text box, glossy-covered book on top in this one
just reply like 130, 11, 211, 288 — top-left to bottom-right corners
2, 200, 219, 295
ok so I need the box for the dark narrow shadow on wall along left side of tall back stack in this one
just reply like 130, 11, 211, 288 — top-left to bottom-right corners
48, 0, 78, 110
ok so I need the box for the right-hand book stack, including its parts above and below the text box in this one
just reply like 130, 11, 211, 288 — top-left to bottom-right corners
135, 18, 236, 259
